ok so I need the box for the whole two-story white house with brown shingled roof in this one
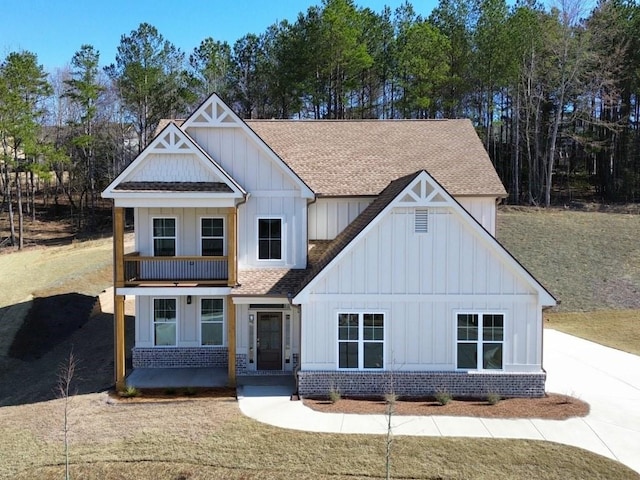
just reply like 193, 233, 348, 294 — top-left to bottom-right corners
103, 95, 556, 396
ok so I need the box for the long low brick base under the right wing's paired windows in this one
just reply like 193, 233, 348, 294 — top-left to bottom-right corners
298, 371, 546, 398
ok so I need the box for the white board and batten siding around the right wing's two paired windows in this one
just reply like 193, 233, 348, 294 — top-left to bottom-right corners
301, 207, 542, 372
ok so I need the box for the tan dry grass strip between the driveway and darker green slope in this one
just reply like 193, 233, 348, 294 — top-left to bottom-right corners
545, 310, 640, 355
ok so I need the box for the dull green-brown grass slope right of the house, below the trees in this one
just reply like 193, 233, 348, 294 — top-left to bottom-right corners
497, 208, 640, 312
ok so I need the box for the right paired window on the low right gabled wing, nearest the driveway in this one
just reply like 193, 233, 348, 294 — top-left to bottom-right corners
456, 313, 504, 370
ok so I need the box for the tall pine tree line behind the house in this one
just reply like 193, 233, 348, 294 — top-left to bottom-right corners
0, 0, 640, 248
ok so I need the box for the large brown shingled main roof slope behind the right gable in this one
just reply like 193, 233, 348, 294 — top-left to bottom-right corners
246, 120, 506, 197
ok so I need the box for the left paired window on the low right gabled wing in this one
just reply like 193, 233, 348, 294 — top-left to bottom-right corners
338, 312, 384, 370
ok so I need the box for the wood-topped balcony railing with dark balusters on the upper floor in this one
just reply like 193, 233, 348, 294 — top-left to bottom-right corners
124, 252, 229, 285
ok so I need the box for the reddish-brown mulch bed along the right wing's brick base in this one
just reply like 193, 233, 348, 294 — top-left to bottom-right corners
303, 394, 589, 420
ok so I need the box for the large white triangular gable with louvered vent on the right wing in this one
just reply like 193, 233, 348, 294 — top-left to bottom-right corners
294, 171, 555, 305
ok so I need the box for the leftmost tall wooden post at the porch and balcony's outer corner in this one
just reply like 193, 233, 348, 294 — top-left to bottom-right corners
113, 207, 125, 390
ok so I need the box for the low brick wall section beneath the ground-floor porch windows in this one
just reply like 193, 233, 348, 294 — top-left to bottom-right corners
132, 347, 229, 368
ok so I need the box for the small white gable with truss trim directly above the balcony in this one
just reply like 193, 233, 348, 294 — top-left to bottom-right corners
102, 123, 246, 206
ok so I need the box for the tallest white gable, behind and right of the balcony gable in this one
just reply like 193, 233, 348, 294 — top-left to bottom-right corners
182, 94, 314, 199
